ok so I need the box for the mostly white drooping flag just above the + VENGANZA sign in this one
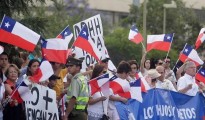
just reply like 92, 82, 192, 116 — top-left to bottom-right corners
29, 60, 54, 83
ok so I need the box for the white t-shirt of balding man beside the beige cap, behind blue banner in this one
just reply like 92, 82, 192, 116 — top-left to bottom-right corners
156, 79, 176, 92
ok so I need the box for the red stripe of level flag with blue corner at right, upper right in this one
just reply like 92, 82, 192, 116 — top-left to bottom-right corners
147, 41, 171, 52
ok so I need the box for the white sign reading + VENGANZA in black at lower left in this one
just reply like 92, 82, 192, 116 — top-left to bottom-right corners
25, 84, 59, 120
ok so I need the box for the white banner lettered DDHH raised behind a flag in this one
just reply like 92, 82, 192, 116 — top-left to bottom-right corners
73, 14, 109, 69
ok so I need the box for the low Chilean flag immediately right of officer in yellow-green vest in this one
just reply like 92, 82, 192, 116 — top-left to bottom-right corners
89, 73, 109, 95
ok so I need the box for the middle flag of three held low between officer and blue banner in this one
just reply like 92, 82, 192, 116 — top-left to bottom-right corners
109, 75, 130, 94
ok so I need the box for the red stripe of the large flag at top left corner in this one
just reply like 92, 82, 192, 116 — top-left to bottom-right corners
0, 29, 36, 52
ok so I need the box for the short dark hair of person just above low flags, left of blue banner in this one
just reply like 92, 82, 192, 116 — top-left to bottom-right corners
117, 61, 131, 73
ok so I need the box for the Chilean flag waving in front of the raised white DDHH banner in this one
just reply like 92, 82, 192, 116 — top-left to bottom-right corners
73, 25, 101, 61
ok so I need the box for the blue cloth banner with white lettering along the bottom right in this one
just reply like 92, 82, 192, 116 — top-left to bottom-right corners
115, 88, 205, 120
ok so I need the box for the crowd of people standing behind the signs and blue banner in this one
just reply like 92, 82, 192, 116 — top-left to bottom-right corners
0, 52, 205, 120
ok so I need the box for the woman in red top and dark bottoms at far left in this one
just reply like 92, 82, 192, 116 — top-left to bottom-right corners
3, 64, 26, 120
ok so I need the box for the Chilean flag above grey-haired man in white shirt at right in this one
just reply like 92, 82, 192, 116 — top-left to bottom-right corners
179, 45, 204, 66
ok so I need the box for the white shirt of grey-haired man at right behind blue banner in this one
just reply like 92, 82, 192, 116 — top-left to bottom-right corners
177, 74, 199, 96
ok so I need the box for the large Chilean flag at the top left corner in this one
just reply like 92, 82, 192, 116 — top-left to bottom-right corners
0, 16, 40, 52
